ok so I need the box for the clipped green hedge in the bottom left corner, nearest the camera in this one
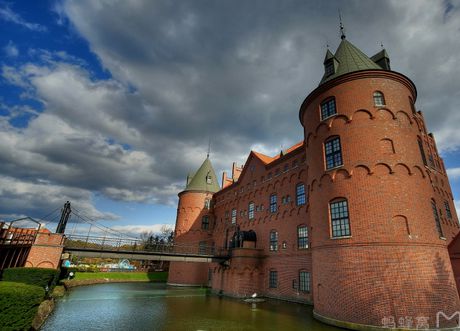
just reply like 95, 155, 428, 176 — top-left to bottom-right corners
0, 281, 45, 330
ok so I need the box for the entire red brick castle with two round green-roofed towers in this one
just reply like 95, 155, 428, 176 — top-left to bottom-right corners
169, 30, 460, 329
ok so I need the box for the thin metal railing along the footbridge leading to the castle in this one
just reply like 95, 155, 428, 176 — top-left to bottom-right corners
64, 235, 228, 256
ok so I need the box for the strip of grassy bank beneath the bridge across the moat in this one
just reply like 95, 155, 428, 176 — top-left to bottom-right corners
72, 271, 168, 282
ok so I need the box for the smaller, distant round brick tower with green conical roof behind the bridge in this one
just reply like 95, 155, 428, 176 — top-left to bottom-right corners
168, 157, 220, 286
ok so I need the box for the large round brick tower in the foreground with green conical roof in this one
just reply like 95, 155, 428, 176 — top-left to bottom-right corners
299, 35, 460, 329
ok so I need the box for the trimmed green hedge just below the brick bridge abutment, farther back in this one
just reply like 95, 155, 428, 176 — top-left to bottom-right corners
2, 268, 59, 289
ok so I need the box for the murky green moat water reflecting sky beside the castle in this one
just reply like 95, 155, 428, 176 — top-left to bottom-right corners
42, 283, 340, 331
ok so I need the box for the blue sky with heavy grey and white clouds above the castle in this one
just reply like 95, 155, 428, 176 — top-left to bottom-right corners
0, 0, 460, 239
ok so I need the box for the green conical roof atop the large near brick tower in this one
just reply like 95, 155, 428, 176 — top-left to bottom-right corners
320, 38, 382, 85
